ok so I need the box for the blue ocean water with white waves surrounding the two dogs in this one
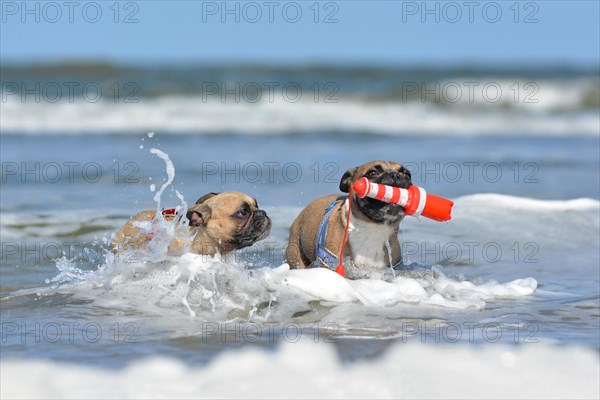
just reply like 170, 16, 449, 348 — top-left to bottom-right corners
0, 65, 600, 397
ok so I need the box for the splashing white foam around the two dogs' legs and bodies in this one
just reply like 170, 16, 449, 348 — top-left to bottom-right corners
23, 248, 537, 322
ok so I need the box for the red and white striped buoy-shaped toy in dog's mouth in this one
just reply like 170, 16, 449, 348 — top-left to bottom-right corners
352, 178, 454, 221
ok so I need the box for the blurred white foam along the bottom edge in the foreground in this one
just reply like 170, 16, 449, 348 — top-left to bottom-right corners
0, 341, 600, 399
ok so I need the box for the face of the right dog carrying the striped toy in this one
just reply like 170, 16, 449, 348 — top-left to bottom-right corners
340, 161, 412, 224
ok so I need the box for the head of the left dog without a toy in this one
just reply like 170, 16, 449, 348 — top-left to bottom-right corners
187, 192, 271, 251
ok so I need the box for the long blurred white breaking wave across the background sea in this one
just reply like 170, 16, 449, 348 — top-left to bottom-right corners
0, 96, 600, 136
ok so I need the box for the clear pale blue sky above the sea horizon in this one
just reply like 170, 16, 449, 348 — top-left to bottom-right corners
0, 0, 600, 66
